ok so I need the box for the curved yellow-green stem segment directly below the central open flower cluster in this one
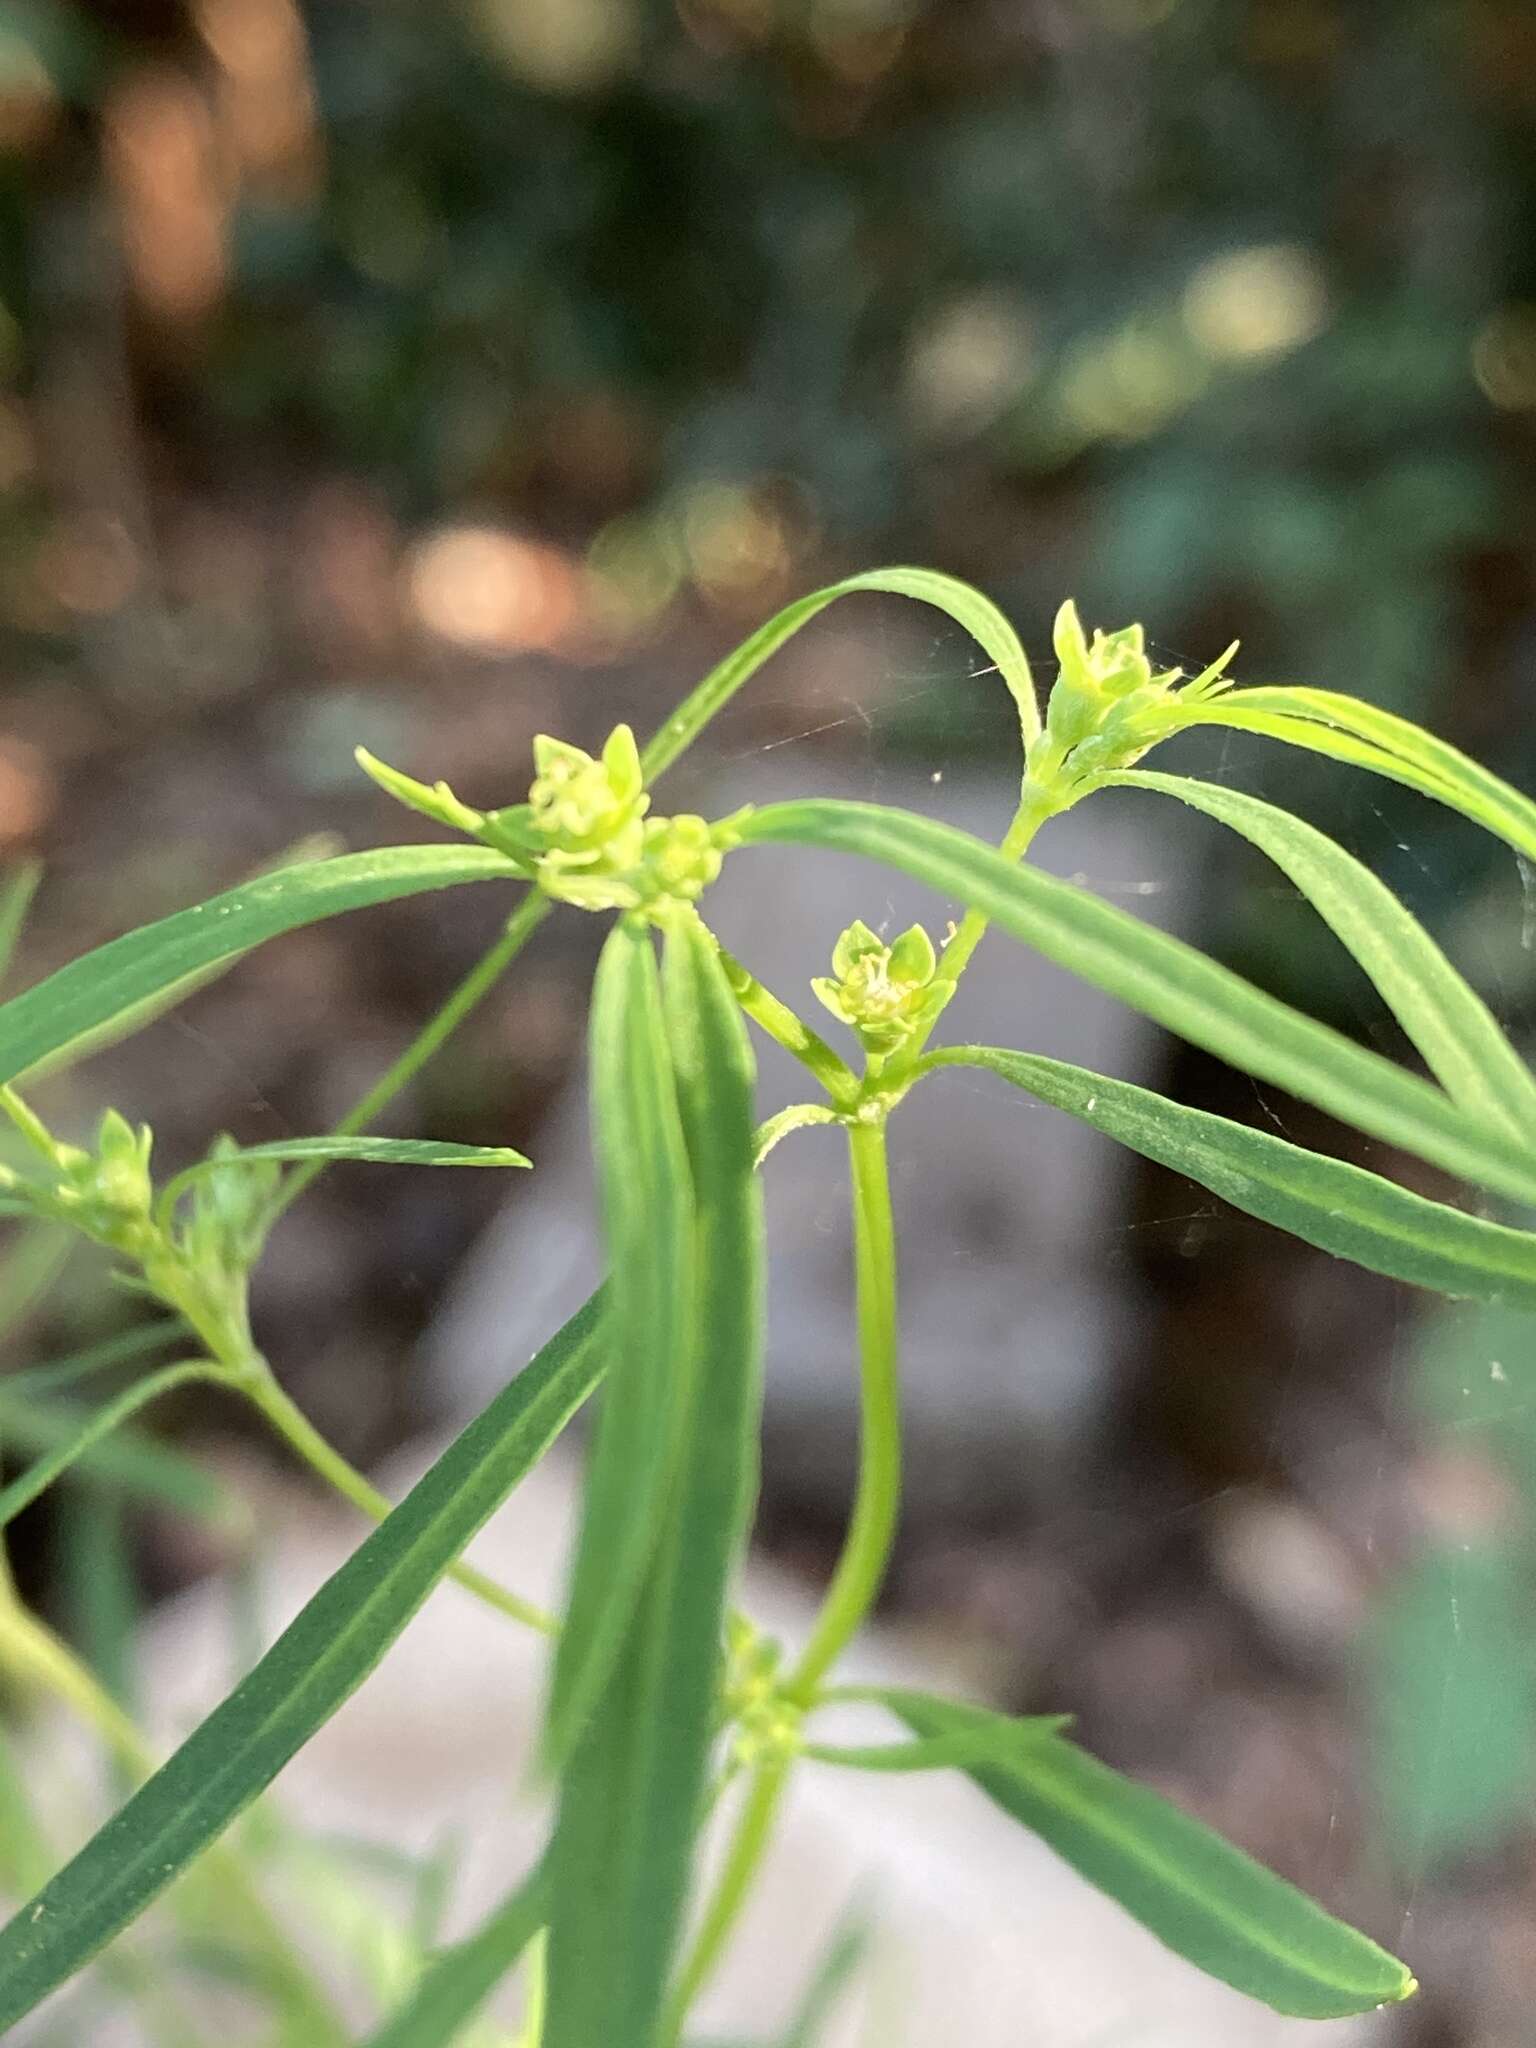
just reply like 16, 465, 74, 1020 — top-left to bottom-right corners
784, 1120, 901, 1708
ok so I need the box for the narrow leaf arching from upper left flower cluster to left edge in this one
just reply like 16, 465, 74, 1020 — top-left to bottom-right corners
0, 846, 514, 1081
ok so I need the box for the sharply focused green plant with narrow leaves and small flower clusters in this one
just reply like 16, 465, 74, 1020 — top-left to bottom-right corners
0, 569, 1536, 2048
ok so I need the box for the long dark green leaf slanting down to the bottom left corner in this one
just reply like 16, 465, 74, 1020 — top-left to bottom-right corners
0, 1294, 602, 2032
